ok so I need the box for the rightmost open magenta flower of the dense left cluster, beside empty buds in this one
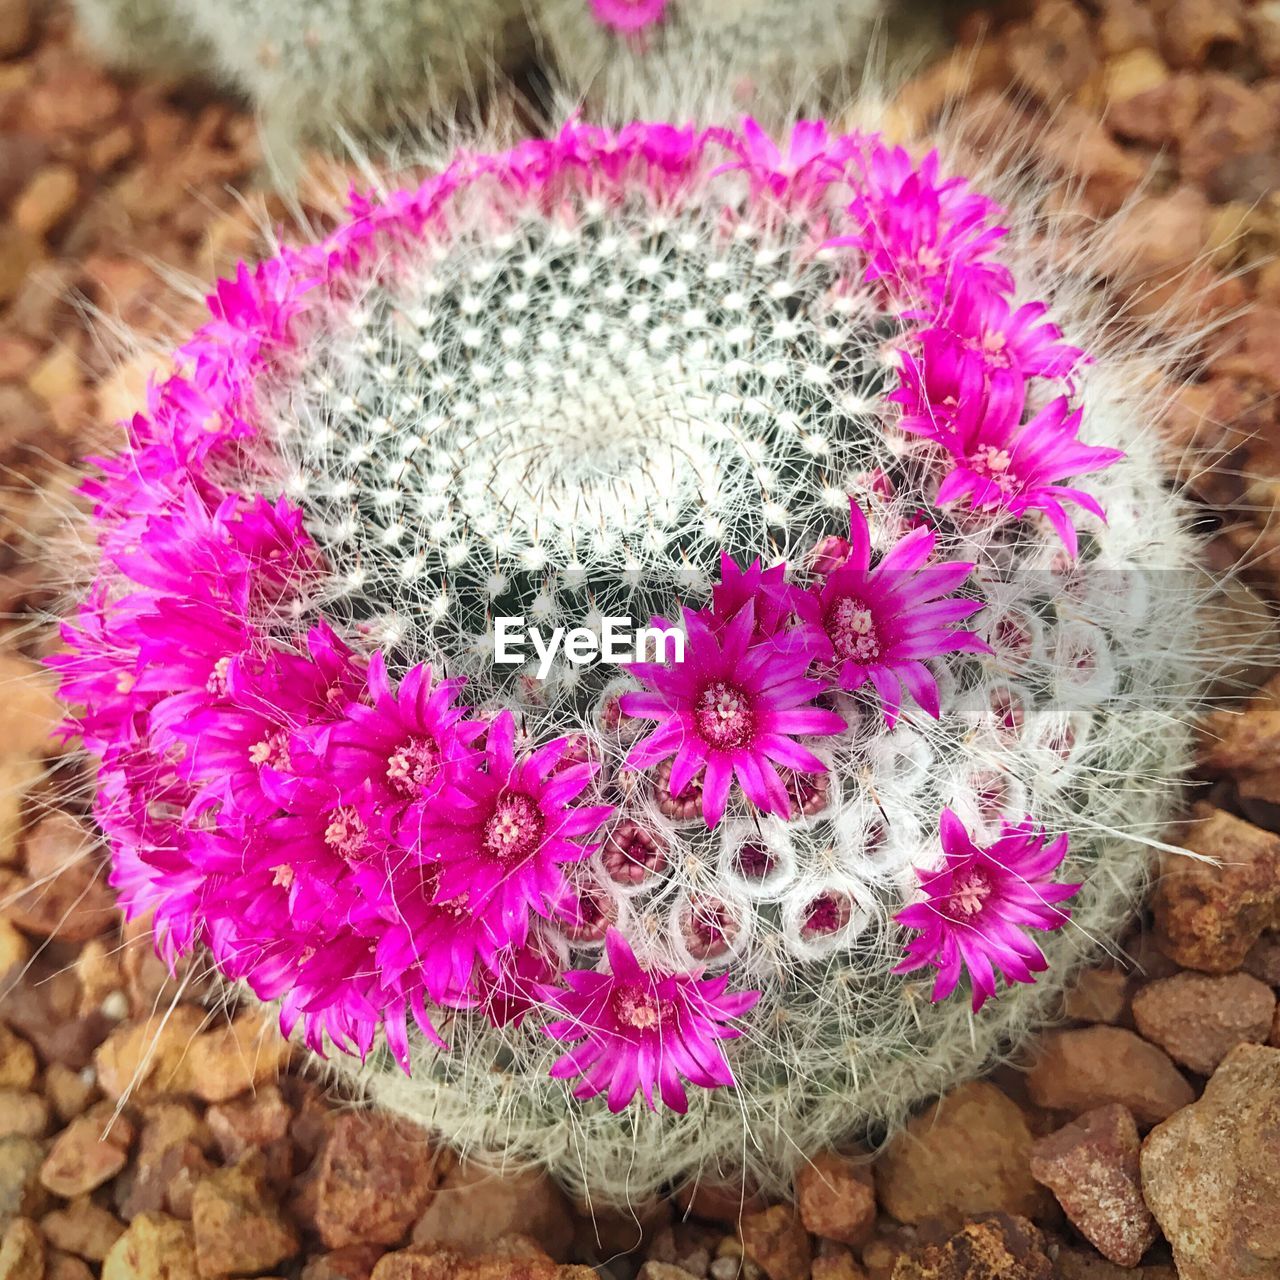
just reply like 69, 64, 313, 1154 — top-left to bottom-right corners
420, 712, 613, 947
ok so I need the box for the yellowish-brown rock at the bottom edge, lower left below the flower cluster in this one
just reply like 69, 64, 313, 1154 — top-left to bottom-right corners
191, 1156, 298, 1277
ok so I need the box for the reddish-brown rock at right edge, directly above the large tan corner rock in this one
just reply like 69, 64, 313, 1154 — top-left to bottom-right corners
1133, 973, 1276, 1075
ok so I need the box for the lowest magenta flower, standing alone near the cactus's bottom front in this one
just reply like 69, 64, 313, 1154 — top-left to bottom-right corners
543, 929, 760, 1112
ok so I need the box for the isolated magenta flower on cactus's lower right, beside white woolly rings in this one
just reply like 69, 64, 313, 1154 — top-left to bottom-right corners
893, 809, 1080, 1012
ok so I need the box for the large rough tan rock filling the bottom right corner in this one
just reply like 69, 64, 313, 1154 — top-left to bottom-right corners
1142, 1044, 1280, 1280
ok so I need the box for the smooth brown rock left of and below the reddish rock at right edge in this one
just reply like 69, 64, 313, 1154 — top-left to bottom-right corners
1027, 1027, 1196, 1125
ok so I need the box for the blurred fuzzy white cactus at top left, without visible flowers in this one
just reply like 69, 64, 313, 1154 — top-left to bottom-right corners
77, 0, 527, 177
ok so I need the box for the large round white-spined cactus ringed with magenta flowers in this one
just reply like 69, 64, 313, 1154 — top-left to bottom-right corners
55, 120, 1218, 1199
